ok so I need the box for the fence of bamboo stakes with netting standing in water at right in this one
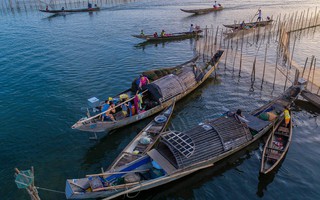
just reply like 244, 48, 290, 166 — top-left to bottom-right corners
195, 8, 320, 92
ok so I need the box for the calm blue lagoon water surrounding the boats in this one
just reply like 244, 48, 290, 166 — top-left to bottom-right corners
0, 0, 320, 200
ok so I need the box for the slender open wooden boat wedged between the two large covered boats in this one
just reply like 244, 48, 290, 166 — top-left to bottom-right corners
108, 102, 175, 171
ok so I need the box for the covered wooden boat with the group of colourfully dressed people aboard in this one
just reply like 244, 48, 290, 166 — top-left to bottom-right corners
72, 50, 224, 133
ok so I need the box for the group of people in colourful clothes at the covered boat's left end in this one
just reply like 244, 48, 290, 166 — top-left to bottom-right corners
100, 74, 150, 122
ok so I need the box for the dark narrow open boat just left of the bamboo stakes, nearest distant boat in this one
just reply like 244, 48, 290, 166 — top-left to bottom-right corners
132, 30, 202, 42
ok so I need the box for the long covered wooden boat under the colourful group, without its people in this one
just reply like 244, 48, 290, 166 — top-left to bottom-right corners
72, 50, 224, 132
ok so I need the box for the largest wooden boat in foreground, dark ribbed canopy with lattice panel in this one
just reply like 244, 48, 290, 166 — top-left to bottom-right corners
65, 86, 300, 199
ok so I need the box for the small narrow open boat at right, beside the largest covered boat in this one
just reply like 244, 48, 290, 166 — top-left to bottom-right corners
260, 110, 292, 174
